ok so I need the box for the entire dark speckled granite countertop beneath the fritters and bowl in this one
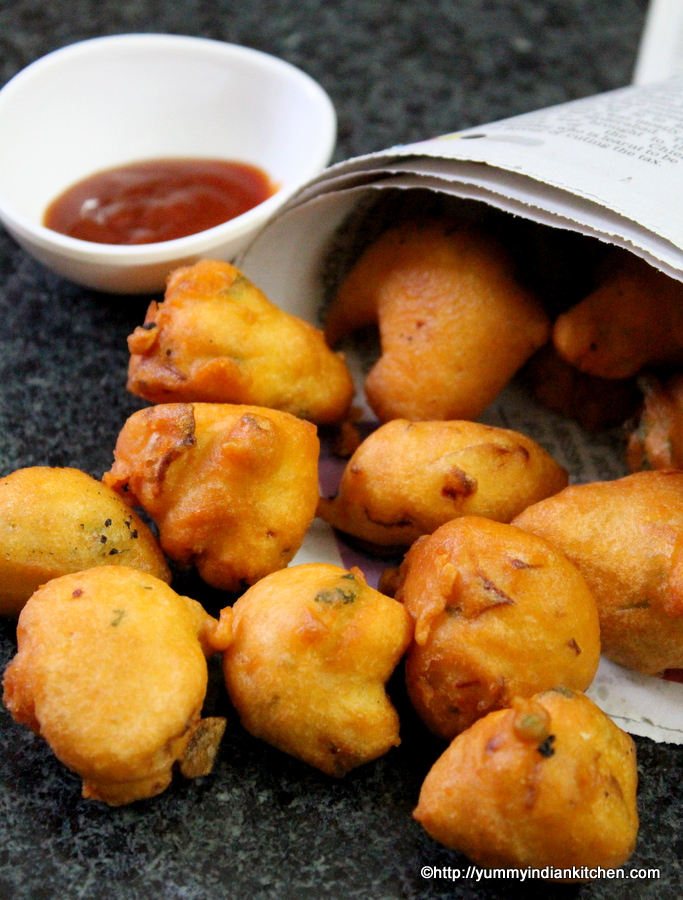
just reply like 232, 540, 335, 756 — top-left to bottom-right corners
0, 0, 683, 900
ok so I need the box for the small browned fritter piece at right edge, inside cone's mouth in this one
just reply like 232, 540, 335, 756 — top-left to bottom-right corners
626, 372, 683, 472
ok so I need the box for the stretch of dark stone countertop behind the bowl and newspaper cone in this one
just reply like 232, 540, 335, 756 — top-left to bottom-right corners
0, 0, 647, 159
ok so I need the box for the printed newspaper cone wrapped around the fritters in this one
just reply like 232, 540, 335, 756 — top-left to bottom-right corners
238, 77, 683, 743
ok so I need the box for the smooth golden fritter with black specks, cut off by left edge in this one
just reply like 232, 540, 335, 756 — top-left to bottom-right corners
0, 466, 171, 616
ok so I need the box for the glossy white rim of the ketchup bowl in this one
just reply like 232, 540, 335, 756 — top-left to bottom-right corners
0, 32, 337, 266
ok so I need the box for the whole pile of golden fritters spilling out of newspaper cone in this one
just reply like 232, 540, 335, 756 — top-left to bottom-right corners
8, 211, 683, 880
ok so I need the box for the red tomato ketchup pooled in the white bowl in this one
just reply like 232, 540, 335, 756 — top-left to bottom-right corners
43, 159, 277, 244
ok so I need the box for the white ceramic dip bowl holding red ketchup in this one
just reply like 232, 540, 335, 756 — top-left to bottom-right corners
0, 34, 336, 293
